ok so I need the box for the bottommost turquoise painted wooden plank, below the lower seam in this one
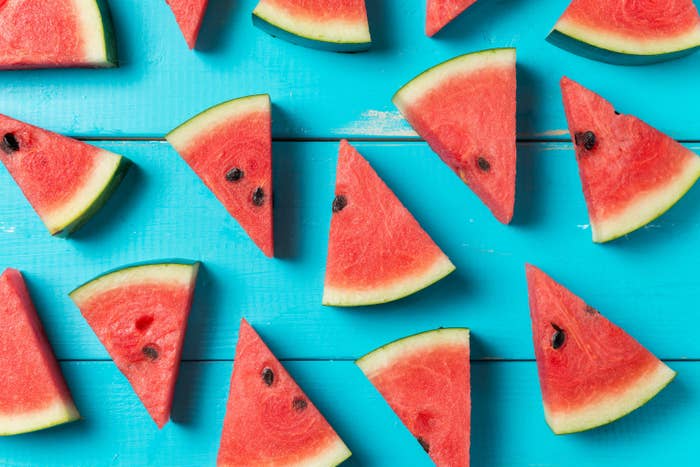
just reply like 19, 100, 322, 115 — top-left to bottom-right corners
0, 362, 700, 467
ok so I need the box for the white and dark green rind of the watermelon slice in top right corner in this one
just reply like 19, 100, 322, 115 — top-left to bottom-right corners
547, 18, 700, 65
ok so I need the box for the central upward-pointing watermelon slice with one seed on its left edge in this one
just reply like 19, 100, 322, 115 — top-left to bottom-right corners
323, 140, 455, 306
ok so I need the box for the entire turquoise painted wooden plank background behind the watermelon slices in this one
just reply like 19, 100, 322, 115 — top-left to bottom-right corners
0, 0, 700, 467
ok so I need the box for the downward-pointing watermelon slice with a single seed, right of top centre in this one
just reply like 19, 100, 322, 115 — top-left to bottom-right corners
393, 49, 516, 224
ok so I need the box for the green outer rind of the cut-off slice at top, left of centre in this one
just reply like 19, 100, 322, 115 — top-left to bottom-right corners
252, 4, 372, 52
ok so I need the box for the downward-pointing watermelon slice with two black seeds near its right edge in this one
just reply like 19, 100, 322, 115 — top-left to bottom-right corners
165, 94, 274, 256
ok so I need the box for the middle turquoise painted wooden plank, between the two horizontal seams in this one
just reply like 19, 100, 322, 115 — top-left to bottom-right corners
0, 142, 700, 359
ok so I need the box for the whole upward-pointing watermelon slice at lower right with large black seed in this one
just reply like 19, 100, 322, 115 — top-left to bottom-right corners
527, 265, 676, 434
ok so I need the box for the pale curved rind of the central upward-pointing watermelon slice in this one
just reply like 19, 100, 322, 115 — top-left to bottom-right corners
322, 253, 456, 307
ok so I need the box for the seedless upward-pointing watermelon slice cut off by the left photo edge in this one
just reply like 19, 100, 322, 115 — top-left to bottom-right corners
0, 269, 80, 436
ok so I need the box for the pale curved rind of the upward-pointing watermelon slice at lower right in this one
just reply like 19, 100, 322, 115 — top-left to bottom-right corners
545, 361, 677, 435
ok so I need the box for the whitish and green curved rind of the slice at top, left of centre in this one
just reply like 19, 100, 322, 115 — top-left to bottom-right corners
252, 1, 372, 52
